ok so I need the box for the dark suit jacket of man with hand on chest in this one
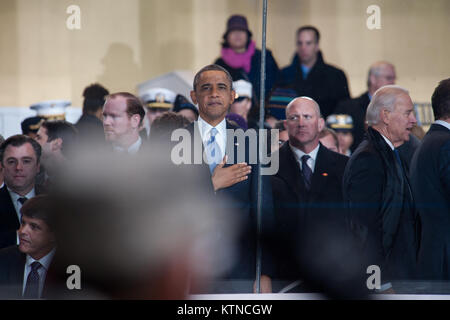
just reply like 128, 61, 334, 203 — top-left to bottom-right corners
187, 122, 273, 279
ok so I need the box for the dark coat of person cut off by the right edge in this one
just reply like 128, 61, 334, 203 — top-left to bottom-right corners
410, 124, 450, 280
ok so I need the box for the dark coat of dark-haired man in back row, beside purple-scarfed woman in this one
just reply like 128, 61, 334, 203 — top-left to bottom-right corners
277, 52, 350, 118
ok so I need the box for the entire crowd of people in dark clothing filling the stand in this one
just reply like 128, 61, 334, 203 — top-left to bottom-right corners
0, 15, 450, 299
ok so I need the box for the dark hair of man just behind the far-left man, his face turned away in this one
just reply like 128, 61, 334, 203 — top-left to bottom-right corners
41, 120, 78, 157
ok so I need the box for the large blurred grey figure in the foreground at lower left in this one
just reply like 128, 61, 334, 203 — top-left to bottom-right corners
47, 145, 236, 299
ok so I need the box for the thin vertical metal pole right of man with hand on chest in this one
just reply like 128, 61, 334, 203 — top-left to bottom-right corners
256, 0, 267, 293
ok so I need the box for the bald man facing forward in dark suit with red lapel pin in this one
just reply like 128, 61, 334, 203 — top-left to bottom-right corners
272, 97, 351, 295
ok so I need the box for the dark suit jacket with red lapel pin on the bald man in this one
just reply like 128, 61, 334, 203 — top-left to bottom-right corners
272, 142, 348, 280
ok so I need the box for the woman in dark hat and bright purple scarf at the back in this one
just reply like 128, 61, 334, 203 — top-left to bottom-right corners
214, 15, 278, 101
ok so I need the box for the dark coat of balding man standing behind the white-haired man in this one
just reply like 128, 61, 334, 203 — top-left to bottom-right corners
335, 91, 370, 152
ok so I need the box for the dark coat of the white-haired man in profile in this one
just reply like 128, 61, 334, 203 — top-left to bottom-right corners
343, 128, 420, 280
